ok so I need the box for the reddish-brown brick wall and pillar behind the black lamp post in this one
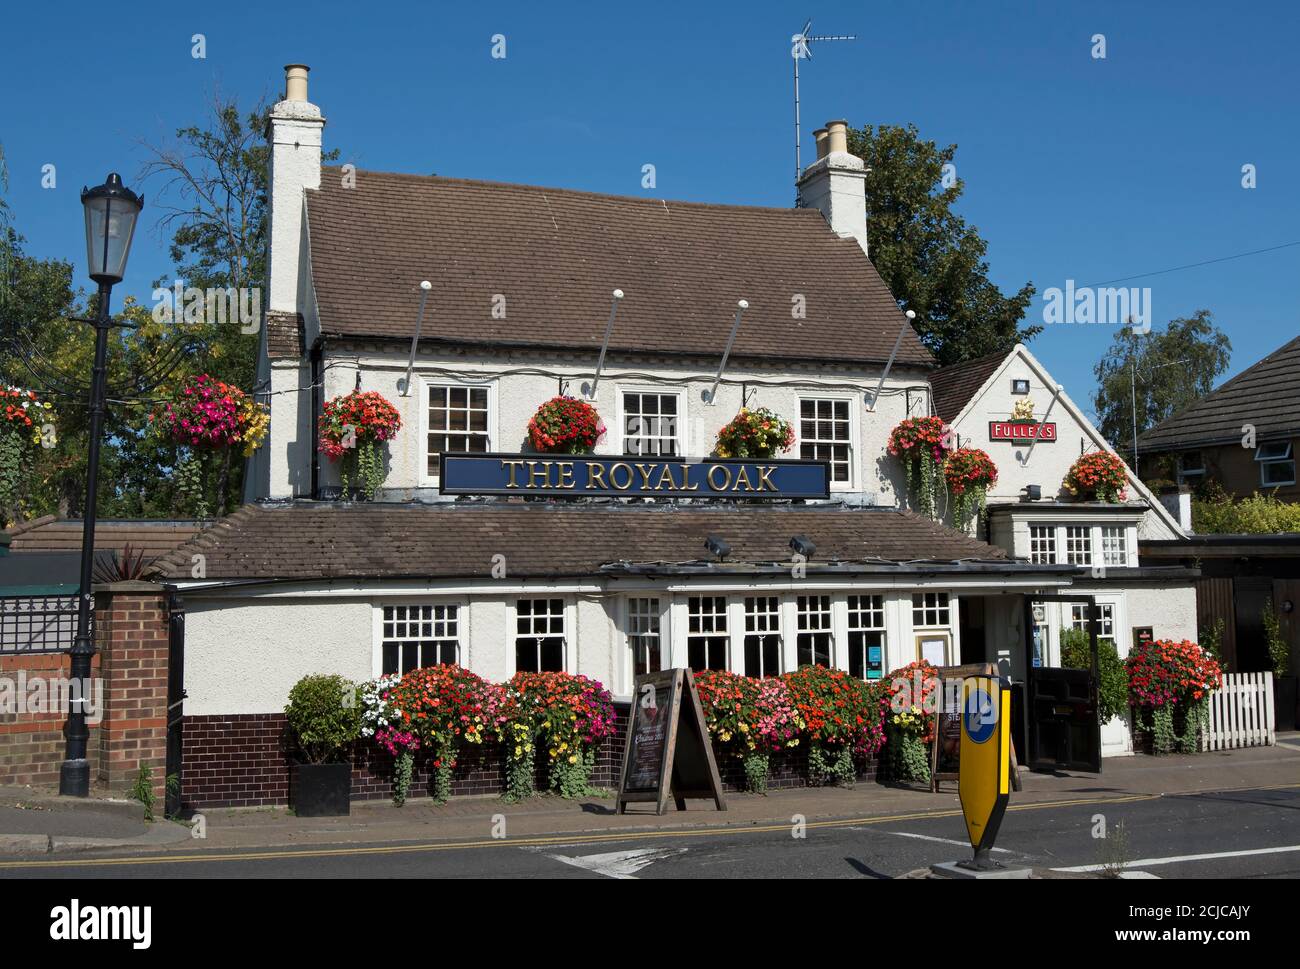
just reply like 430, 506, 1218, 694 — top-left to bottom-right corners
0, 583, 168, 796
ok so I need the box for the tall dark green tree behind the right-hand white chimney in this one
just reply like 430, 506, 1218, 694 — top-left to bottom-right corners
849, 125, 1043, 365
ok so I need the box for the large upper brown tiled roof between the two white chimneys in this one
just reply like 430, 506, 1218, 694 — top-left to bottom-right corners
307, 168, 933, 367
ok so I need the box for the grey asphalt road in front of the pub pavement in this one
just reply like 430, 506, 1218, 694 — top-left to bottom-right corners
0, 787, 1300, 879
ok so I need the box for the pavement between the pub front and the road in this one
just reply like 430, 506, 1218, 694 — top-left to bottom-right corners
0, 735, 1300, 855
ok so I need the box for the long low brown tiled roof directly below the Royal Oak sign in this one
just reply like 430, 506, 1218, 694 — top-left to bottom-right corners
157, 502, 1006, 579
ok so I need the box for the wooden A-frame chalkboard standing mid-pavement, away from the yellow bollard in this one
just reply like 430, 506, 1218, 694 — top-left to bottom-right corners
619, 670, 727, 814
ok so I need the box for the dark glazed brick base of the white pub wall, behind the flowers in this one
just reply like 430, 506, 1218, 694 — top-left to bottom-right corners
181, 704, 875, 808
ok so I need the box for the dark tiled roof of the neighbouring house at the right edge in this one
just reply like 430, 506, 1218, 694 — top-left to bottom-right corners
1138, 337, 1300, 453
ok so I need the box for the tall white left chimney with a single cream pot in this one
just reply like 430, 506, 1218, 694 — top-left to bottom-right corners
267, 64, 325, 313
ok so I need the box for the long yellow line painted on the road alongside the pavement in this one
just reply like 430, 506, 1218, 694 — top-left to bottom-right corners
0, 784, 1170, 870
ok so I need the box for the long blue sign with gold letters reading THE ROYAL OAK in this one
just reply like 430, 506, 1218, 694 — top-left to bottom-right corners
438, 454, 831, 498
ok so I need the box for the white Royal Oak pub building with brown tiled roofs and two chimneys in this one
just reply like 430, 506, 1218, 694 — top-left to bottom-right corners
152, 65, 1196, 804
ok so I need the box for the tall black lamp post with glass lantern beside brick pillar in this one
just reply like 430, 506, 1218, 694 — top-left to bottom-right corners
59, 172, 144, 797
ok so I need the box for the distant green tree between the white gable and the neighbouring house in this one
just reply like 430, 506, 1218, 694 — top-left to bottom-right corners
1092, 310, 1232, 453
